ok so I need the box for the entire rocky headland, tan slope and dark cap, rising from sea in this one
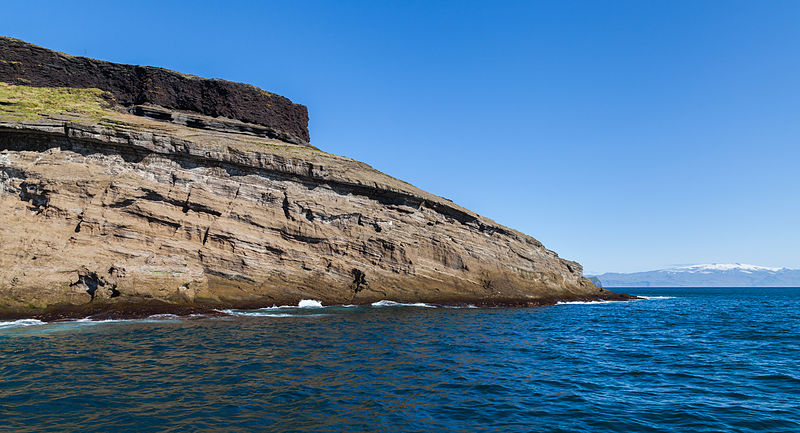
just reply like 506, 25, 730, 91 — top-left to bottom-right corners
0, 37, 632, 320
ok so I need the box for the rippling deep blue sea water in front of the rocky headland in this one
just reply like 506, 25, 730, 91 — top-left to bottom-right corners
0, 288, 800, 432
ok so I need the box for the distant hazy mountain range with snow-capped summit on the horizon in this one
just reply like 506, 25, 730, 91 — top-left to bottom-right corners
589, 263, 800, 287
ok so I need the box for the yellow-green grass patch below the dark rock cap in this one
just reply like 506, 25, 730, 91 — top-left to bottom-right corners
0, 83, 110, 120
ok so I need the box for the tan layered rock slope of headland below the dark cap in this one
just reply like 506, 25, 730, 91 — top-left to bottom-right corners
0, 101, 616, 316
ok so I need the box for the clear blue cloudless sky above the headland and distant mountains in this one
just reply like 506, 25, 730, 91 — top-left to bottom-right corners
0, 0, 800, 272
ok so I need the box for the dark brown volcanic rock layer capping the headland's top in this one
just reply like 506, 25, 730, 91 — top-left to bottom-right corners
0, 36, 309, 143
